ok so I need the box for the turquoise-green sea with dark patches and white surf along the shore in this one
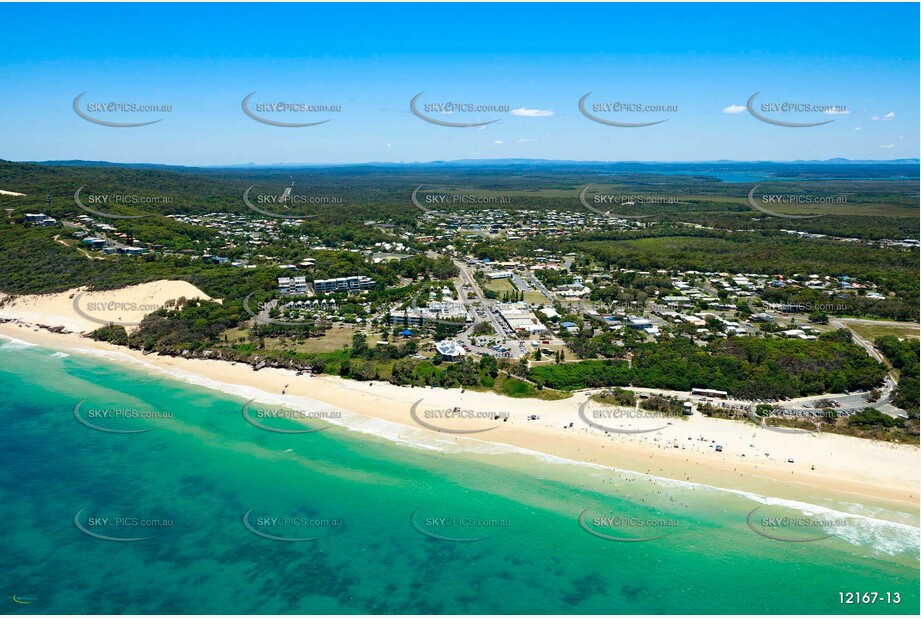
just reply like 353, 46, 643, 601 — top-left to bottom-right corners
0, 339, 919, 614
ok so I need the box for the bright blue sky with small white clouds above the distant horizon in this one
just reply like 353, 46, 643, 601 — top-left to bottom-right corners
0, 3, 921, 166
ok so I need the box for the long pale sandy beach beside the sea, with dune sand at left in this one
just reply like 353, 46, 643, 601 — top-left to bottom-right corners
0, 282, 921, 514
